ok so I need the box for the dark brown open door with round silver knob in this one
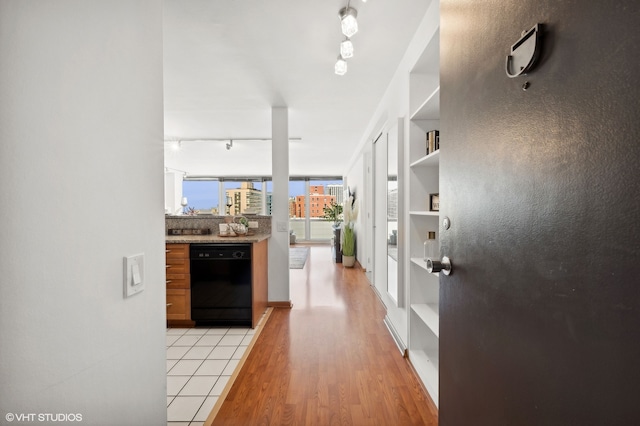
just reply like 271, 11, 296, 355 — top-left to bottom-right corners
440, 0, 640, 426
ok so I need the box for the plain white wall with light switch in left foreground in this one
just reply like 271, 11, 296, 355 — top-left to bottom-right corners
0, 0, 166, 426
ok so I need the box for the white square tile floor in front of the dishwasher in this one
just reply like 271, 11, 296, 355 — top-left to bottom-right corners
167, 328, 256, 426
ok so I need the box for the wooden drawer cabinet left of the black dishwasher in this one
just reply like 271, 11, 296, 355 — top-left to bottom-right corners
166, 244, 191, 326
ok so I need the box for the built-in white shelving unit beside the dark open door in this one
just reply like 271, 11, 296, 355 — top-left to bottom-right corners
405, 26, 440, 405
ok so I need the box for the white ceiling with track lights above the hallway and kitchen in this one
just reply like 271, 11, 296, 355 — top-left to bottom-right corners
164, 0, 429, 176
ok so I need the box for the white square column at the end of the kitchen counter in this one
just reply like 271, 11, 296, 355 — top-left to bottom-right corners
269, 107, 291, 302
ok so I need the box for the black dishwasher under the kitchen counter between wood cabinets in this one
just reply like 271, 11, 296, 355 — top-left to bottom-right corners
189, 244, 251, 327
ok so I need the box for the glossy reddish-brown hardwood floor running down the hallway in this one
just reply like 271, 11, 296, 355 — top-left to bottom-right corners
213, 245, 438, 426
